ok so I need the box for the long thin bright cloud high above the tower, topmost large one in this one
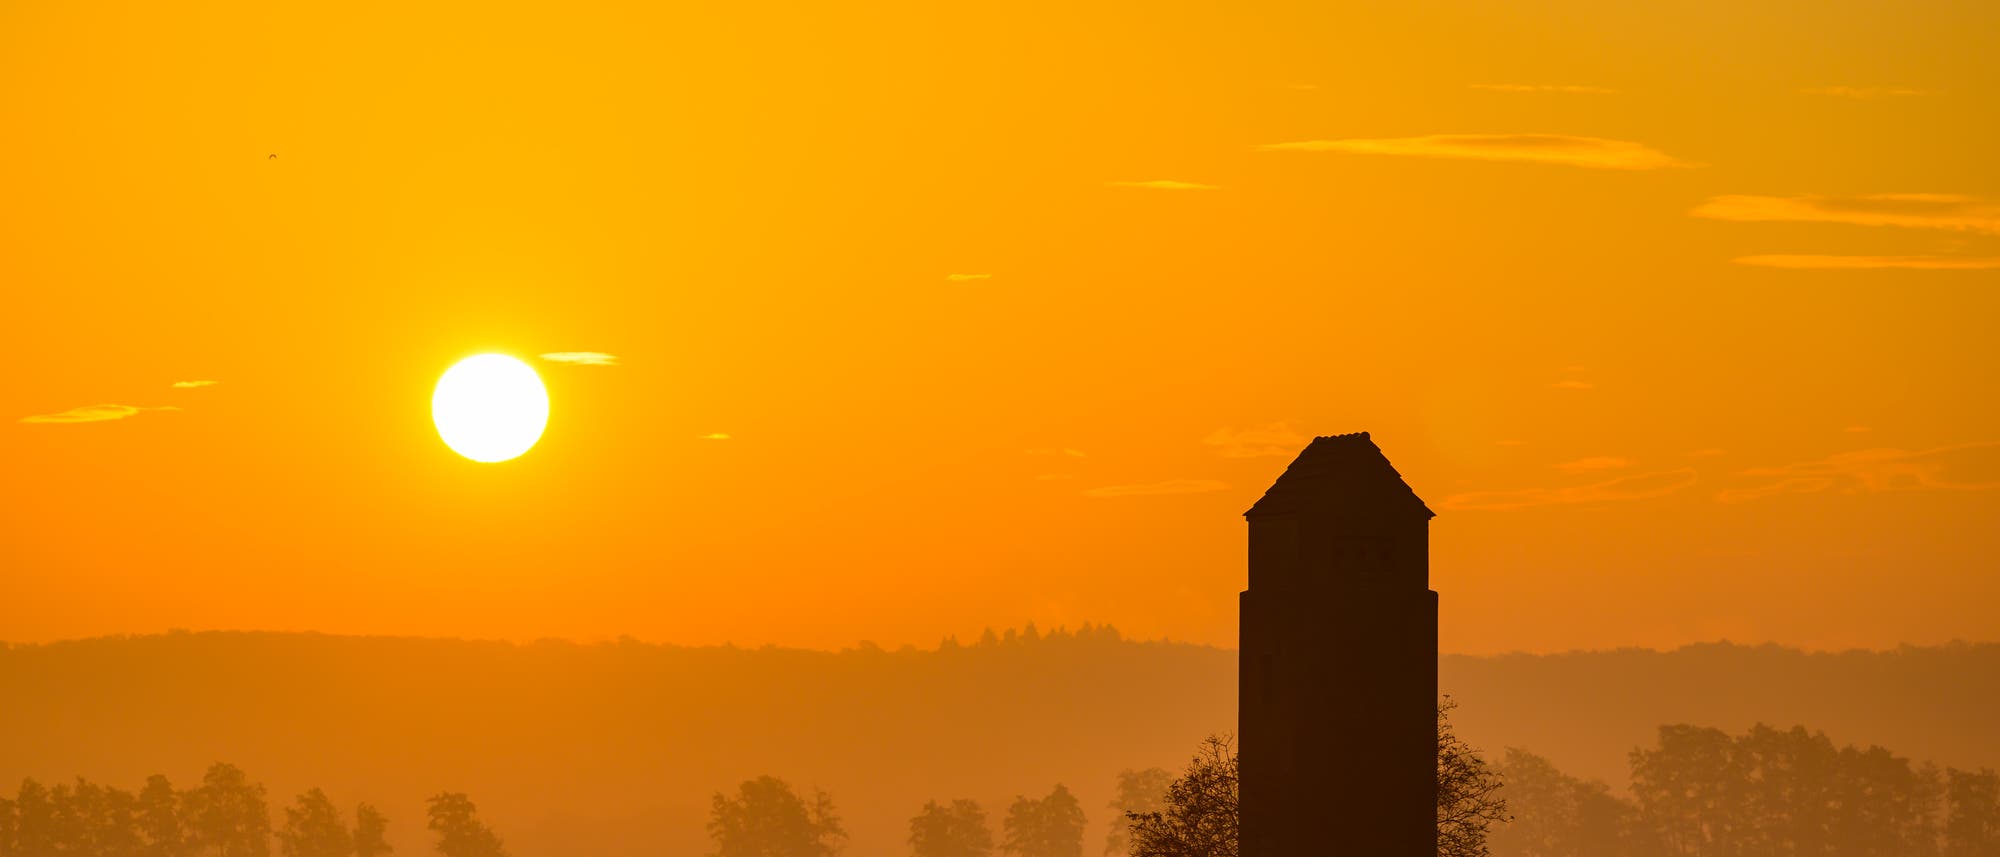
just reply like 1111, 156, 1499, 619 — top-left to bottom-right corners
1258, 134, 1694, 170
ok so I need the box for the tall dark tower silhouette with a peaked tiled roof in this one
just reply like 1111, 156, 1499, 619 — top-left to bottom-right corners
1238, 433, 1438, 857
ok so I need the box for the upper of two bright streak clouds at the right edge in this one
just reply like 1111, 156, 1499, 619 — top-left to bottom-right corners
1690, 194, 2000, 234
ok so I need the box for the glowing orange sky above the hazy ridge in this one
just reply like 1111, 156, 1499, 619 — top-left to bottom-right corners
0, 0, 2000, 653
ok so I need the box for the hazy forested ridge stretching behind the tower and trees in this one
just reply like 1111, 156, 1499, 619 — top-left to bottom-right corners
0, 627, 2000, 857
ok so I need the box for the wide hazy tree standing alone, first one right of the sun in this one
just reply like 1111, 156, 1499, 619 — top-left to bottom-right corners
708, 775, 848, 857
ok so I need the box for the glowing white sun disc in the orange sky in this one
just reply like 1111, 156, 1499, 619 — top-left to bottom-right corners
430, 354, 548, 463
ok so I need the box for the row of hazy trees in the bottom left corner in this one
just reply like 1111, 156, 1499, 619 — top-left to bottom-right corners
0, 763, 506, 857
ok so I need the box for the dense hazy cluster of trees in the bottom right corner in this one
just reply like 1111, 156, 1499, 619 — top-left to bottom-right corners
1490, 725, 2000, 857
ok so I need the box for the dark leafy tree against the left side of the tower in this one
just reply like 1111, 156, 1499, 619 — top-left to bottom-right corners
1124, 735, 1240, 857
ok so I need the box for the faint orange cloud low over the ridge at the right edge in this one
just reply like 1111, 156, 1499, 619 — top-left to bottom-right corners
1716, 441, 2000, 503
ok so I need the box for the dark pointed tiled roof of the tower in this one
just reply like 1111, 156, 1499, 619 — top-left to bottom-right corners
1244, 431, 1438, 521
